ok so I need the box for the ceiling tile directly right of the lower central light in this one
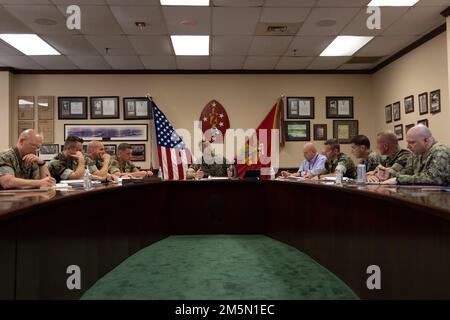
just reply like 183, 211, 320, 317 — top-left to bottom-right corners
212, 36, 253, 56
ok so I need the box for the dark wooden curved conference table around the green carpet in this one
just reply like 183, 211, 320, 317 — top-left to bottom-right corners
0, 178, 450, 299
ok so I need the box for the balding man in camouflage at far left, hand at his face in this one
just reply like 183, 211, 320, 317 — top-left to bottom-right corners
0, 129, 56, 189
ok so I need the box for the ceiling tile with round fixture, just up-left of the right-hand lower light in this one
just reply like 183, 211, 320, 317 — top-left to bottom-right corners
298, 8, 360, 36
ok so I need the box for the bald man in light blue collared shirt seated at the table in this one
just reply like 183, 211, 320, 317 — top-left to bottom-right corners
281, 142, 327, 179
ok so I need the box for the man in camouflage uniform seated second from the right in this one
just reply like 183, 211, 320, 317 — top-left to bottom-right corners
367, 130, 411, 182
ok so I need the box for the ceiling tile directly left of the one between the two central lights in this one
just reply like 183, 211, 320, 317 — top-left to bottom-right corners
111, 6, 167, 35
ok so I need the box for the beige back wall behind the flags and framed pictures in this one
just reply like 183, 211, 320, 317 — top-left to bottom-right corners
14, 75, 376, 167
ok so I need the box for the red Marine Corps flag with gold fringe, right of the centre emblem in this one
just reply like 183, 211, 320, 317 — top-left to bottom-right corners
237, 97, 284, 178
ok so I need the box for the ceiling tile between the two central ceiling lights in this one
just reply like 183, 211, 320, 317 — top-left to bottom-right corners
162, 6, 211, 35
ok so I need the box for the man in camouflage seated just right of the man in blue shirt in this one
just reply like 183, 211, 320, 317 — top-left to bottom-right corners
318, 139, 356, 179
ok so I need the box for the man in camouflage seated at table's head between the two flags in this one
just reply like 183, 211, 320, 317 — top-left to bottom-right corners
186, 141, 235, 179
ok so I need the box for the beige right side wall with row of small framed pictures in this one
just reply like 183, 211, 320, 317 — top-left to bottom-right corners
373, 33, 450, 147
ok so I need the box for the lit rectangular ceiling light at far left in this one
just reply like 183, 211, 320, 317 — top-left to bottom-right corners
0, 33, 60, 56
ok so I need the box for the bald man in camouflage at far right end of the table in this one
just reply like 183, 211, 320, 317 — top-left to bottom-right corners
384, 125, 450, 186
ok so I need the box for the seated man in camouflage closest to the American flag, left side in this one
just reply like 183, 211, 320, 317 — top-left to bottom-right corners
109, 143, 153, 178
